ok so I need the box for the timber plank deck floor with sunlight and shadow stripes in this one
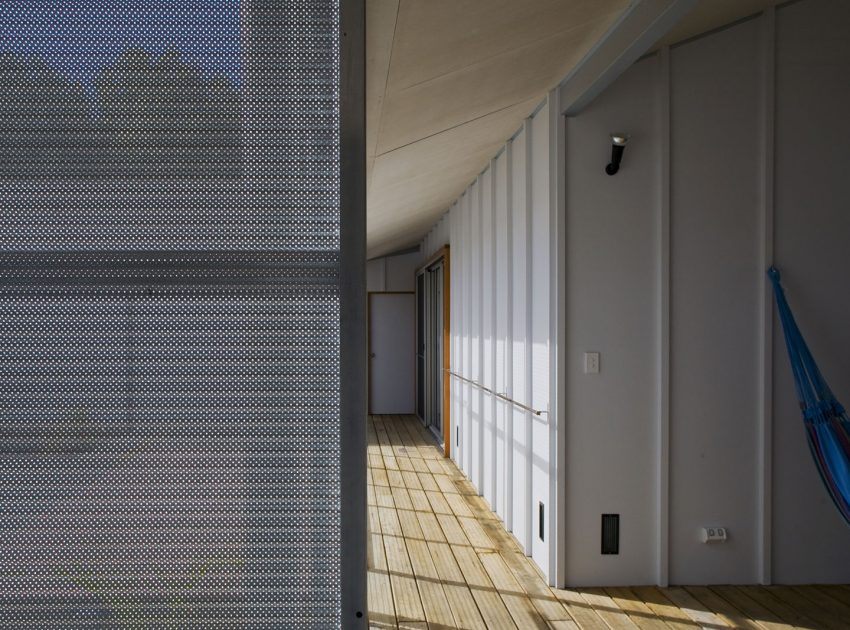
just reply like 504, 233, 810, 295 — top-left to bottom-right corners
368, 416, 850, 630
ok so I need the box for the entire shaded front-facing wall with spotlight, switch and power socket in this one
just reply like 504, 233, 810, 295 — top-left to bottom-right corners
563, 0, 850, 585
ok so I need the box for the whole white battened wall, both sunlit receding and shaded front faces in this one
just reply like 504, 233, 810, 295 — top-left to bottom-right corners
420, 0, 850, 585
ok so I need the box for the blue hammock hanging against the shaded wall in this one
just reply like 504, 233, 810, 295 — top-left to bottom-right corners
767, 267, 850, 524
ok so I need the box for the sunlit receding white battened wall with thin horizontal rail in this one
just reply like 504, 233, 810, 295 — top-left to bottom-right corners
420, 97, 555, 581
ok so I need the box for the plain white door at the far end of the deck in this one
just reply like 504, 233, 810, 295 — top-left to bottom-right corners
369, 293, 416, 414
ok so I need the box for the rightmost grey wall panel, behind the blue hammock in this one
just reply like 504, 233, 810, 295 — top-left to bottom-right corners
773, 0, 850, 582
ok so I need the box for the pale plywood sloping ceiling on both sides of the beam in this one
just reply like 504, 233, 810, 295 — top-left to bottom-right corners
366, 0, 776, 257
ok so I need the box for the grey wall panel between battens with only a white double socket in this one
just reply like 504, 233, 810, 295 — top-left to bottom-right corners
670, 20, 764, 583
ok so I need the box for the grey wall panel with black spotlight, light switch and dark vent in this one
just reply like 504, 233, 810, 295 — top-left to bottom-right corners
565, 58, 661, 584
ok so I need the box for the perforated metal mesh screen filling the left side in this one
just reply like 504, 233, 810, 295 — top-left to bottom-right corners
0, 0, 341, 628
